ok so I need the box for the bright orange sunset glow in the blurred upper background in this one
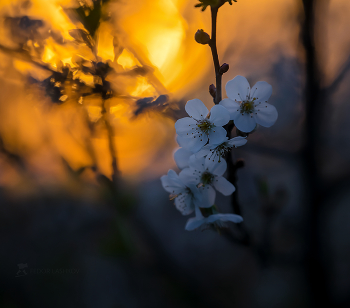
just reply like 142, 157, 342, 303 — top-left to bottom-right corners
0, 0, 346, 188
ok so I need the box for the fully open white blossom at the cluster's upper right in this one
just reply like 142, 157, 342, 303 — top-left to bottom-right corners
219, 76, 278, 133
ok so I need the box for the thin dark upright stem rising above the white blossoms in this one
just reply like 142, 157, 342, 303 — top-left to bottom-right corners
209, 7, 222, 105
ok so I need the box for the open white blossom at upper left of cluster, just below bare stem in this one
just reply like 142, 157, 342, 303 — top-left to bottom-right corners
175, 99, 230, 152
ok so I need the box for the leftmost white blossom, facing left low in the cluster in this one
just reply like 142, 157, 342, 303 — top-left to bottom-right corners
160, 170, 214, 215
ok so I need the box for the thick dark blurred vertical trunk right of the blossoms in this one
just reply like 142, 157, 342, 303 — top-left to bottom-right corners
301, 0, 331, 307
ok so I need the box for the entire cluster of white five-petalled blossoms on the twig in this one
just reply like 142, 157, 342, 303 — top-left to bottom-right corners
161, 76, 278, 231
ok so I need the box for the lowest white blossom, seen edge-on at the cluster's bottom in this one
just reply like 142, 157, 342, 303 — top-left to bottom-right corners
185, 207, 243, 231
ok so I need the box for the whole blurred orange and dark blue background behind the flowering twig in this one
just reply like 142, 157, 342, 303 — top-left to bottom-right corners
0, 0, 350, 308
